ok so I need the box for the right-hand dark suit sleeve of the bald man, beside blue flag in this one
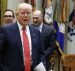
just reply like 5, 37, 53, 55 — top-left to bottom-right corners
45, 28, 55, 56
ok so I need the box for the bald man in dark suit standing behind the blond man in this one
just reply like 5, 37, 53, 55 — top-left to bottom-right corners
32, 10, 55, 71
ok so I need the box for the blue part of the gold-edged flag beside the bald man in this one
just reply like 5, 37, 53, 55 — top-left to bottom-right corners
53, 21, 64, 53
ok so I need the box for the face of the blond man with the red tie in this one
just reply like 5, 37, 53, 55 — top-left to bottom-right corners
16, 8, 31, 26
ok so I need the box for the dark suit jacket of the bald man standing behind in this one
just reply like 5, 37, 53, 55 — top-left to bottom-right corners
41, 24, 55, 54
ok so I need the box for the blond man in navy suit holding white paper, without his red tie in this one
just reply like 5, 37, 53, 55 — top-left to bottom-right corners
0, 3, 46, 71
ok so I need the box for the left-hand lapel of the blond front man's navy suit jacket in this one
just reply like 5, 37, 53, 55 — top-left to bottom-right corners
12, 23, 23, 57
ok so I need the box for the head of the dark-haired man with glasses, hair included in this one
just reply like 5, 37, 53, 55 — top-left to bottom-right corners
4, 9, 14, 25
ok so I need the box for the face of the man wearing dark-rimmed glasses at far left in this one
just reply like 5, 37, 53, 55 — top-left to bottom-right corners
4, 11, 14, 24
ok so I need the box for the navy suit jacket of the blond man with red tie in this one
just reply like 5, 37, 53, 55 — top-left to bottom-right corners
0, 23, 43, 71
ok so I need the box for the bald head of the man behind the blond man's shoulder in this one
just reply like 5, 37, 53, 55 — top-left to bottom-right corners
33, 10, 43, 26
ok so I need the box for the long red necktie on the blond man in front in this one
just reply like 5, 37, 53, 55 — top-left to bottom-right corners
23, 28, 31, 71
